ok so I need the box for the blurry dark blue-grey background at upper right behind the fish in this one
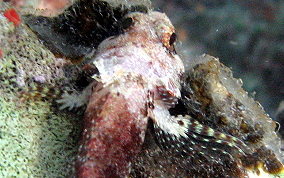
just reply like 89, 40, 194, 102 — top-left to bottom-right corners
152, 0, 284, 117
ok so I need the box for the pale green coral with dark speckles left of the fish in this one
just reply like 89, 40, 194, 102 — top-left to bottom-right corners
0, 3, 82, 177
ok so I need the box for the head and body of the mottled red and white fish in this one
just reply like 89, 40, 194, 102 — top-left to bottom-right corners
76, 11, 186, 178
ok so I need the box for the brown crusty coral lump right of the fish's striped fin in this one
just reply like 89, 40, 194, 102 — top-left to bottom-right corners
184, 56, 284, 174
